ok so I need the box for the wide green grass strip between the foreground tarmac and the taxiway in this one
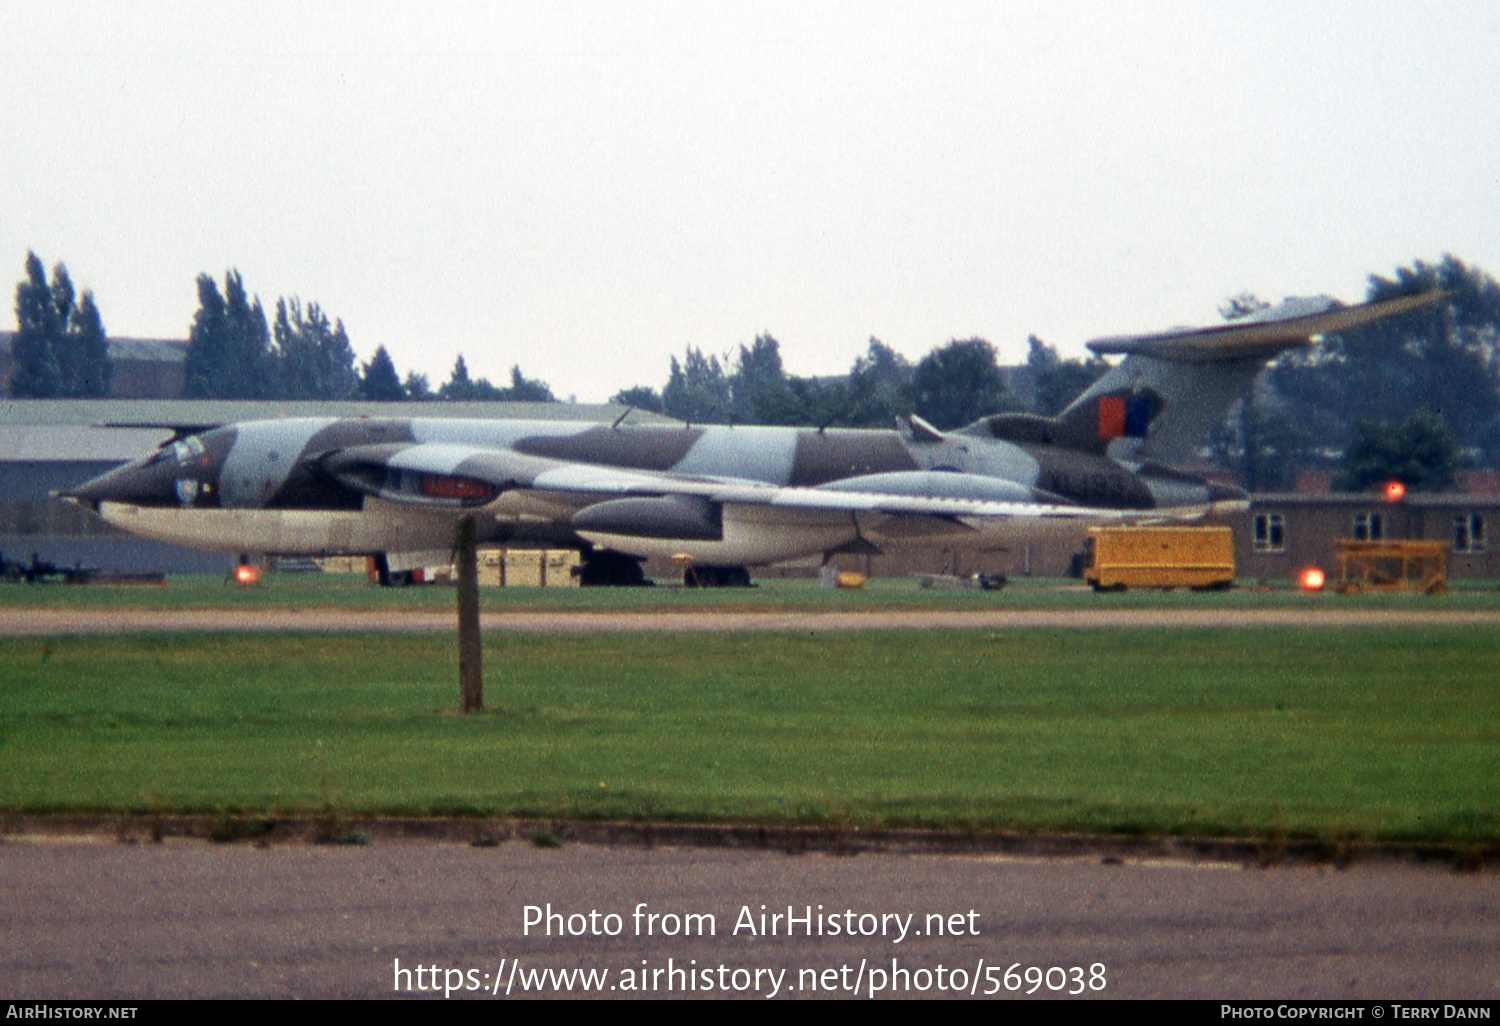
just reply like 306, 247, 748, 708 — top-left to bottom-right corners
0, 624, 1500, 843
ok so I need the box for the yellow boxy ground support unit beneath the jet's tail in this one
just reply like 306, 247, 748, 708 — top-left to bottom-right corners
1083, 527, 1235, 591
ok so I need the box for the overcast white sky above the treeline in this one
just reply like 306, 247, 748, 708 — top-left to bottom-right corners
0, 0, 1500, 401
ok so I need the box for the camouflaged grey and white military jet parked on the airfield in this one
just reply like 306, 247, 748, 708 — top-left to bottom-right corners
66, 293, 1439, 584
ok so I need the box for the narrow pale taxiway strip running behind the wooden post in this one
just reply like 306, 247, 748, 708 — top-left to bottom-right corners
0, 609, 1500, 638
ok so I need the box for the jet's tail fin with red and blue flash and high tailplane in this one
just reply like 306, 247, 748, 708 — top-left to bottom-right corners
1056, 291, 1445, 464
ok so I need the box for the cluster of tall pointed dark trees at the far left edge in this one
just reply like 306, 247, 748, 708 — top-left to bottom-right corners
11, 252, 114, 399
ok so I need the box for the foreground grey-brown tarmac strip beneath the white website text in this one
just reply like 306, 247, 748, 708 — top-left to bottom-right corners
0, 837, 1500, 1001
